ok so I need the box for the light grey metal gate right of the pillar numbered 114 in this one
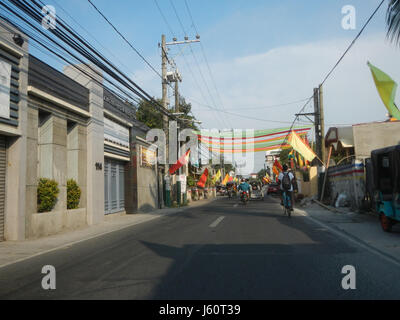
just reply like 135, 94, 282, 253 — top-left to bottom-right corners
104, 159, 125, 214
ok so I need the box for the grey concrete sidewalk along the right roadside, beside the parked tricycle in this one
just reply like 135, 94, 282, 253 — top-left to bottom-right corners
295, 203, 400, 262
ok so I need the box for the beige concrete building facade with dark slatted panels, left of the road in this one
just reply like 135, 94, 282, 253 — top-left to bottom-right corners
0, 23, 160, 241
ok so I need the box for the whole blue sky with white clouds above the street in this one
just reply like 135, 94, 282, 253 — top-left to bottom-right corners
11, 0, 400, 171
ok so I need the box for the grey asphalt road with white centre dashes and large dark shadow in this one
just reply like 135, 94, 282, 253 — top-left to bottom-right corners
0, 198, 400, 300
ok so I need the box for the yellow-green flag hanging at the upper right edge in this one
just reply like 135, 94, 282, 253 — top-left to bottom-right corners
367, 62, 400, 120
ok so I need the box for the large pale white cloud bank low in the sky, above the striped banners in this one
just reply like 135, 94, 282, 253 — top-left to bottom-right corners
134, 33, 400, 174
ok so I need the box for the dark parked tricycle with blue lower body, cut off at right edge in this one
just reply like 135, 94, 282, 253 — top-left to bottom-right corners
371, 145, 400, 232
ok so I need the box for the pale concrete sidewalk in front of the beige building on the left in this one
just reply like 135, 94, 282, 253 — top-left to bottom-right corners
0, 198, 217, 268
